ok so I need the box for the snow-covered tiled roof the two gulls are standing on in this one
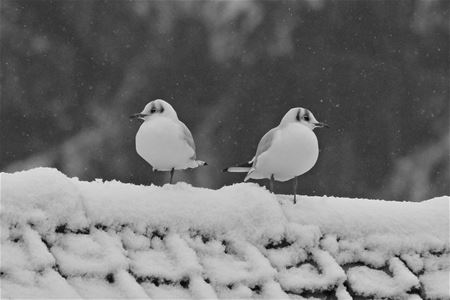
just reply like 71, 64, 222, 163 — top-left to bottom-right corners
0, 168, 450, 299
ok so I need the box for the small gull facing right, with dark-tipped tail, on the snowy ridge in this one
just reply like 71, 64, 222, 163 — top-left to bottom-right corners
224, 107, 328, 203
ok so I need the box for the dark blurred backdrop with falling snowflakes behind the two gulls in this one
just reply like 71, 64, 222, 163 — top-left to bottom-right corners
0, 0, 450, 201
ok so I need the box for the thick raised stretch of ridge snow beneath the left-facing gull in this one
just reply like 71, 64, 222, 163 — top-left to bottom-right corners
78, 173, 286, 240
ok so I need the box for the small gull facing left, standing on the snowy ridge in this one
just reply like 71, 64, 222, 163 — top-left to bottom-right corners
130, 99, 206, 183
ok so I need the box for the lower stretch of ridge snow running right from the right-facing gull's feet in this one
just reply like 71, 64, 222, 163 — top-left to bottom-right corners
284, 196, 449, 249
